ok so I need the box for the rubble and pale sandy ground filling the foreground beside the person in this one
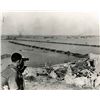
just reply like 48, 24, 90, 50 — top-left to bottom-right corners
23, 52, 100, 89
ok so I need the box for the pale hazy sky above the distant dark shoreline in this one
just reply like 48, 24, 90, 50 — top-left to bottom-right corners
2, 12, 99, 35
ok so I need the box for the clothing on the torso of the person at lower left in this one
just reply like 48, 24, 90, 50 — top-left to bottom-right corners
1, 64, 24, 90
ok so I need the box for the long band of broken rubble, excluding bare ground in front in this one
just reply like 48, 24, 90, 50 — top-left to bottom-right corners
24, 53, 100, 89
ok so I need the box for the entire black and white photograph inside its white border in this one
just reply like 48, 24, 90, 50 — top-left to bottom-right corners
0, 11, 100, 90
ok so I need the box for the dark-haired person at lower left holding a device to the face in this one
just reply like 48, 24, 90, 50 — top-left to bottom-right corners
1, 53, 26, 90
